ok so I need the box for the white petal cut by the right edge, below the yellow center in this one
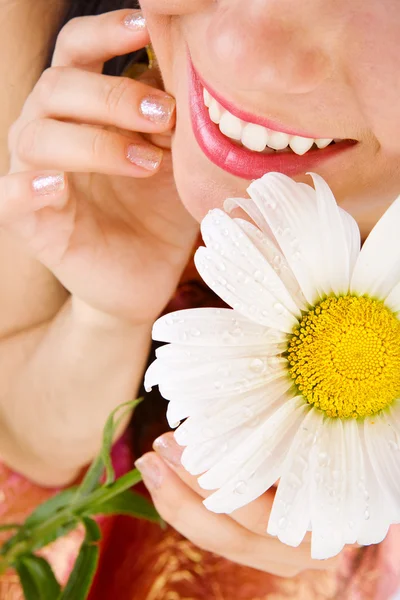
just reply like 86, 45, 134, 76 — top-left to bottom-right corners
364, 412, 400, 516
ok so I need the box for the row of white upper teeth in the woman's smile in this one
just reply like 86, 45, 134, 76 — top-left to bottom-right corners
204, 88, 333, 156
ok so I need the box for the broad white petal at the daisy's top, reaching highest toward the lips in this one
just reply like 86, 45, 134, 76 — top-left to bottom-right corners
248, 173, 326, 304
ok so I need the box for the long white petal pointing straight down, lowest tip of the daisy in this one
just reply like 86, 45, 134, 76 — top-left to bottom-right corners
311, 418, 346, 559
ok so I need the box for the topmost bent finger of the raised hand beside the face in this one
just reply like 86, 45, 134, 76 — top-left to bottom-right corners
52, 10, 150, 73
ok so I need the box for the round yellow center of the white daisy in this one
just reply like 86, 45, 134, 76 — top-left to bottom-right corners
287, 296, 400, 418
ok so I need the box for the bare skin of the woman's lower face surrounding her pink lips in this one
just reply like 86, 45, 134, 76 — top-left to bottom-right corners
141, 0, 400, 237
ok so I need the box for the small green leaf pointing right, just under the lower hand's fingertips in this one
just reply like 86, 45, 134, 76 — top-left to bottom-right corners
88, 490, 161, 523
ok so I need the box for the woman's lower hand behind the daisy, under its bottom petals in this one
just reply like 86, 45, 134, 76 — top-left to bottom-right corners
136, 433, 340, 577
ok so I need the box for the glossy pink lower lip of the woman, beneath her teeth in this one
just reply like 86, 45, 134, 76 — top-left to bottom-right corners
189, 59, 355, 180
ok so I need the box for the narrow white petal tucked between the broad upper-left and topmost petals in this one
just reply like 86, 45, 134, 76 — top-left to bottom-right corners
235, 219, 308, 311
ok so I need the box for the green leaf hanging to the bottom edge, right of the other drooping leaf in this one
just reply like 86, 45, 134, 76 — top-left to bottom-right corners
58, 518, 100, 600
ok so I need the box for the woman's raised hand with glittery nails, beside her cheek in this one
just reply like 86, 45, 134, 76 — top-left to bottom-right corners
0, 10, 197, 325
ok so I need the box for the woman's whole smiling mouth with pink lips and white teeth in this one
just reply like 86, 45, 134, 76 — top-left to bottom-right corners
189, 58, 357, 180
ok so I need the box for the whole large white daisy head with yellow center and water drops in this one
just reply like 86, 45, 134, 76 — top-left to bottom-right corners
146, 173, 400, 559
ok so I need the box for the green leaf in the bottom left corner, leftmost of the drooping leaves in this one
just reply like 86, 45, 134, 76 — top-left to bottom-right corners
14, 554, 61, 600
